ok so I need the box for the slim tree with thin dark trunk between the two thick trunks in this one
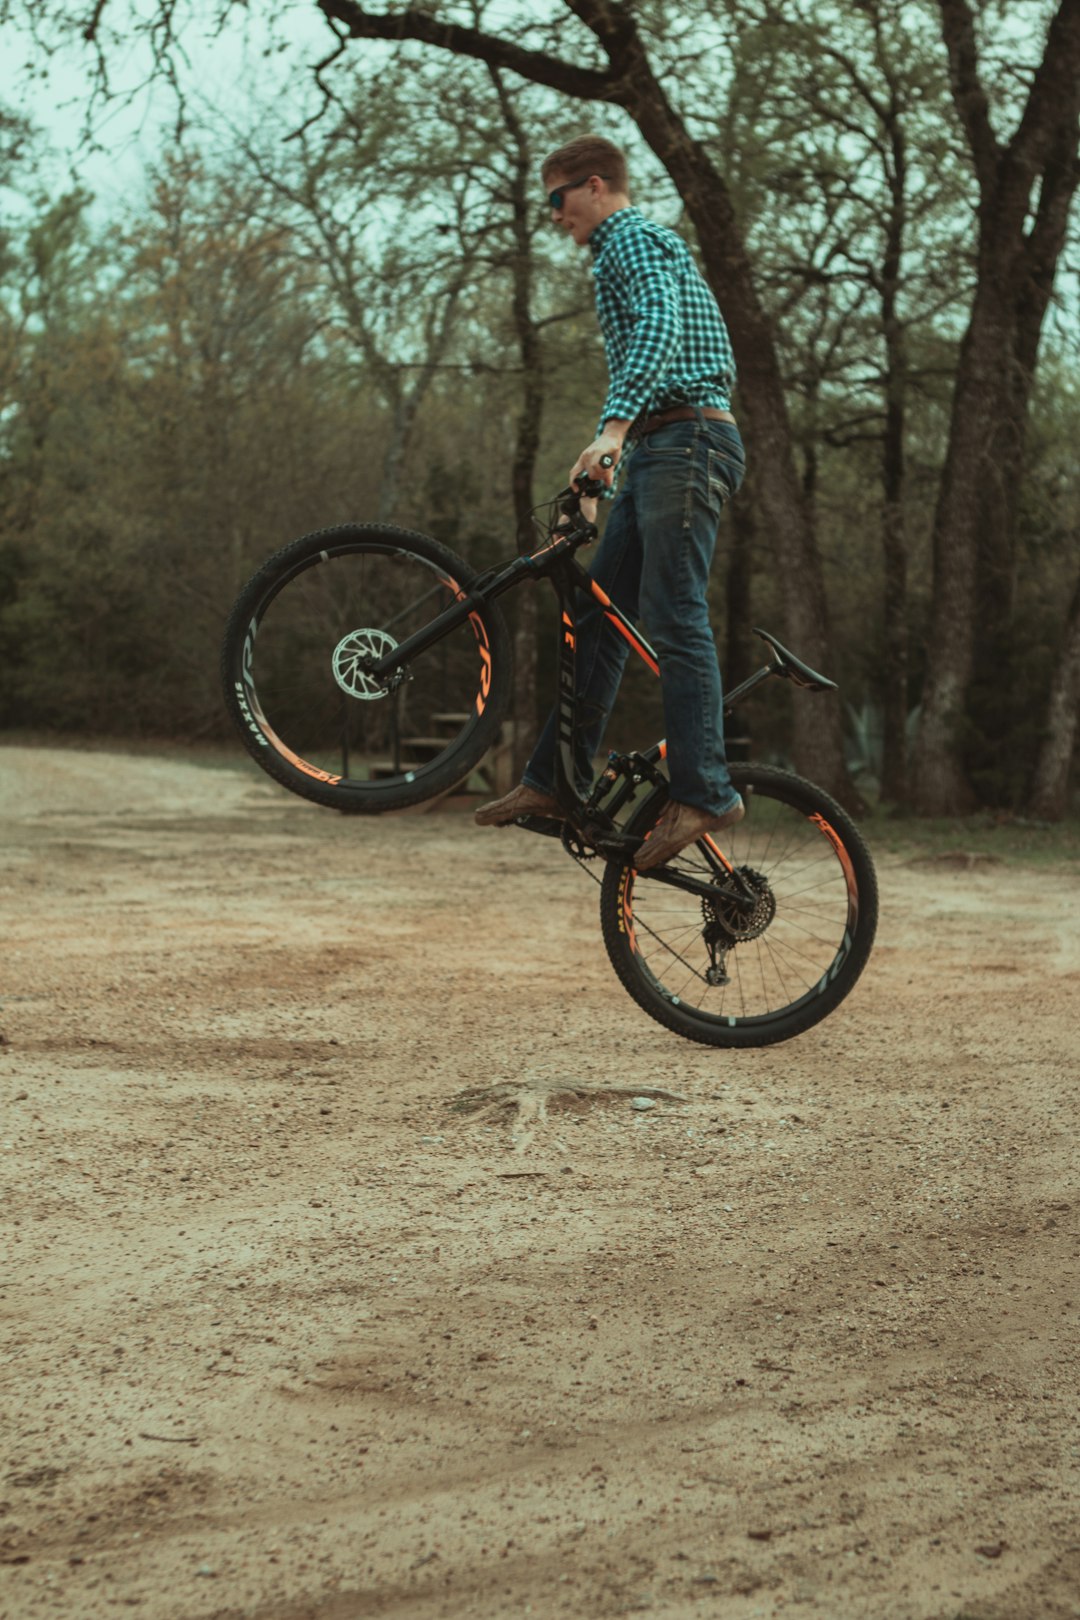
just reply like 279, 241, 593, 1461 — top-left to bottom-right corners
717, 0, 968, 804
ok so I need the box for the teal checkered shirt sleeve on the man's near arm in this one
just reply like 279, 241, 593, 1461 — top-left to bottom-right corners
601, 232, 682, 423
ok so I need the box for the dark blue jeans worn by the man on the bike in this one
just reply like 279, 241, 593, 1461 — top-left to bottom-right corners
523, 416, 746, 815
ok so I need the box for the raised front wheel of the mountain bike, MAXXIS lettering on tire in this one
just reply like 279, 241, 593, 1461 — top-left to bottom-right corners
222, 525, 512, 813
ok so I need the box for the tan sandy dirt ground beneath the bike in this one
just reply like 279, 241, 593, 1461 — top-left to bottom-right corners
0, 747, 1080, 1620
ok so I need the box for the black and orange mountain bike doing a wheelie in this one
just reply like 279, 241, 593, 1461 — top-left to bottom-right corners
222, 481, 878, 1047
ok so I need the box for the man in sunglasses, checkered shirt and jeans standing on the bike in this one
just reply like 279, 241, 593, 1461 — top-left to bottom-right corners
476, 134, 745, 872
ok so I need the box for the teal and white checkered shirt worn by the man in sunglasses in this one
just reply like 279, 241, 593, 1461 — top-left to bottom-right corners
589, 207, 735, 428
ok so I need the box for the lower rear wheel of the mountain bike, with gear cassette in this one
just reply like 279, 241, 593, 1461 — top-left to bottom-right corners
601, 765, 878, 1047
